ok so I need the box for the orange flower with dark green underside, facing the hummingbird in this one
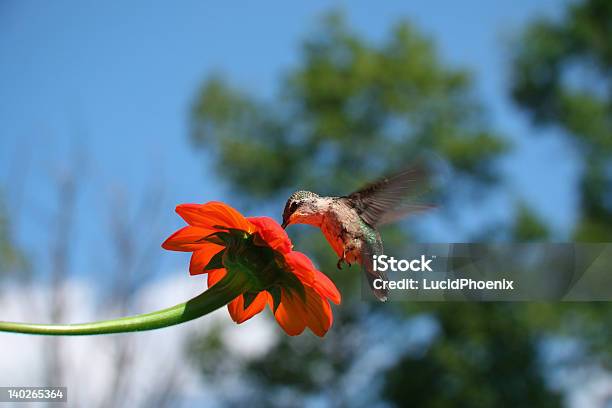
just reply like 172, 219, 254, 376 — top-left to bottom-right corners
162, 202, 340, 336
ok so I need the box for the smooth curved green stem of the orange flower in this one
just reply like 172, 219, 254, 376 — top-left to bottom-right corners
0, 273, 248, 336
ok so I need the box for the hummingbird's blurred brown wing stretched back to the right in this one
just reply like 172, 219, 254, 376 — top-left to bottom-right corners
347, 164, 434, 227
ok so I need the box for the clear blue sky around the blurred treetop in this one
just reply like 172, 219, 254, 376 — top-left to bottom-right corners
0, 0, 578, 278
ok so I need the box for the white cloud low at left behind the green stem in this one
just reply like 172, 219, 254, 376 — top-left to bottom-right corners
0, 271, 278, 407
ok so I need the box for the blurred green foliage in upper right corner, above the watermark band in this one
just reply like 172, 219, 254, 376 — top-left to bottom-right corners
512, 0, 612, 241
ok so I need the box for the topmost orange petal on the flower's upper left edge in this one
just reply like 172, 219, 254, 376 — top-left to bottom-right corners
176, 201, 255, 232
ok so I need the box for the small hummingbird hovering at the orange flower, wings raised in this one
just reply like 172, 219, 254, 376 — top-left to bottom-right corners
282, 166, 431, 302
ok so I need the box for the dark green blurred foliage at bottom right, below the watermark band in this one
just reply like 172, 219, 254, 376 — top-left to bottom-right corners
384, 304, 560, 408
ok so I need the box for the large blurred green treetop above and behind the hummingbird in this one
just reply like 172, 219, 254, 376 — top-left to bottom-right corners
192, 14, 506, 200
